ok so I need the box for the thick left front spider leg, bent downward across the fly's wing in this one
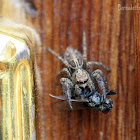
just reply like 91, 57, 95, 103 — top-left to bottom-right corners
60, 78, 74, 110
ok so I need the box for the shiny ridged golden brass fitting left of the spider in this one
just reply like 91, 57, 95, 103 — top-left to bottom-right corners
0, 23, 36, 140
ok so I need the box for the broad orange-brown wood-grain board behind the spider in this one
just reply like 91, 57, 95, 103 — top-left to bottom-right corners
1, 0, 136, 140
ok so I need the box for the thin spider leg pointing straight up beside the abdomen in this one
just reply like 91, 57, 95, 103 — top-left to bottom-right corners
83, 30, 87, 63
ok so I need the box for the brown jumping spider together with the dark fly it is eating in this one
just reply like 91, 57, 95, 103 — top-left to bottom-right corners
47, 31, 116, 111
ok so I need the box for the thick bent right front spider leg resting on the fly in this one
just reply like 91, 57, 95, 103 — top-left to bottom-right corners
91, 69, 106, 100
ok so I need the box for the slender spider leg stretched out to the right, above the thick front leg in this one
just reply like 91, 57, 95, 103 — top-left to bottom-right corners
87, 61, 111, 72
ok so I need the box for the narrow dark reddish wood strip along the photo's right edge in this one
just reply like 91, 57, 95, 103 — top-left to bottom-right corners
133, 0, 140, 139
